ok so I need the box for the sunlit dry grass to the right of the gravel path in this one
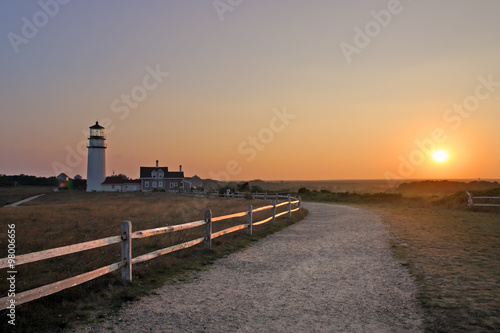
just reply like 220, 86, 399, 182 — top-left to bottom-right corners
370, 205, 500, 332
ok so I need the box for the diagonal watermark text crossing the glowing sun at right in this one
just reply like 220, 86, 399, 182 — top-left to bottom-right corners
384, 74, 500, 187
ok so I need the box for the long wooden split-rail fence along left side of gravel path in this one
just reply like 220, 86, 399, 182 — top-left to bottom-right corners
0, 195, 302, 310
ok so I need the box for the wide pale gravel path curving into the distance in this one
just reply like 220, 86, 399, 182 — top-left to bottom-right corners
78, 203, 423, 333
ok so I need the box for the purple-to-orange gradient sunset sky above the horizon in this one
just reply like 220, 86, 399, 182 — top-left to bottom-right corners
0, 0, 500, 180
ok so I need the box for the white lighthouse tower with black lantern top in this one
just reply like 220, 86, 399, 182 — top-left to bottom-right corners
87, 121, 106, 192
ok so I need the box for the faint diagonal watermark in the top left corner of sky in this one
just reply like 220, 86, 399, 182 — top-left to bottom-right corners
7, 0, 70, 54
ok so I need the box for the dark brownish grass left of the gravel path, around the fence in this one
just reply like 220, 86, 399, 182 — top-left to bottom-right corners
0, 191, 306, 332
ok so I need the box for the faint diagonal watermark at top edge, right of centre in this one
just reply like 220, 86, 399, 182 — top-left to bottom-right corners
339, 0, 412, 64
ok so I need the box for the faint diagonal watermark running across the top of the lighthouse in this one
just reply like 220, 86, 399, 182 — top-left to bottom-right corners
52, 64, 170, 175
